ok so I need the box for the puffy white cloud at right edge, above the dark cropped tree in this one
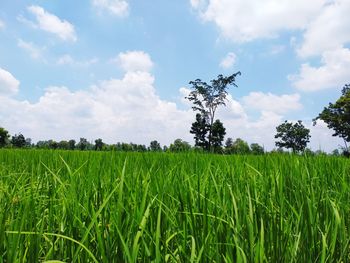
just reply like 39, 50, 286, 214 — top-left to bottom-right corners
289, 48, 350, 91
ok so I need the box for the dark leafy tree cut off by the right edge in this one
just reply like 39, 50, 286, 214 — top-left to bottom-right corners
314, 84, 350, 151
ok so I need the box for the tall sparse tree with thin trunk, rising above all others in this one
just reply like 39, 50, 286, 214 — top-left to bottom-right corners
187, 72, 241, 150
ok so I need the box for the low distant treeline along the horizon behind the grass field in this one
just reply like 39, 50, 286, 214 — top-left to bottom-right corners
0, 127, 342, 156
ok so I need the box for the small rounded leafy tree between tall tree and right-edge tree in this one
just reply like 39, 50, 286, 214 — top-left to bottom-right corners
275, 120, 311, 153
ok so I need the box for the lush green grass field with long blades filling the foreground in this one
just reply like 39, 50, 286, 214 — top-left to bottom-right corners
0, 150, 350, 263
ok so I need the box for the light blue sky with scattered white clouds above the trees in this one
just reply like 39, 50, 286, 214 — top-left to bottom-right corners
0, 0, 350, 151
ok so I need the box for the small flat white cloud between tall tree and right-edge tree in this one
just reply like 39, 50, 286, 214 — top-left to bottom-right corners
242, 92, 302, 114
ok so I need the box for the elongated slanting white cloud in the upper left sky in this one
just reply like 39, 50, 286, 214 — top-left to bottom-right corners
26, 5, 77, 42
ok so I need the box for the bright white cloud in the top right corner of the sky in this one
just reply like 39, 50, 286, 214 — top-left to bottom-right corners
297, 0, 350, 58
